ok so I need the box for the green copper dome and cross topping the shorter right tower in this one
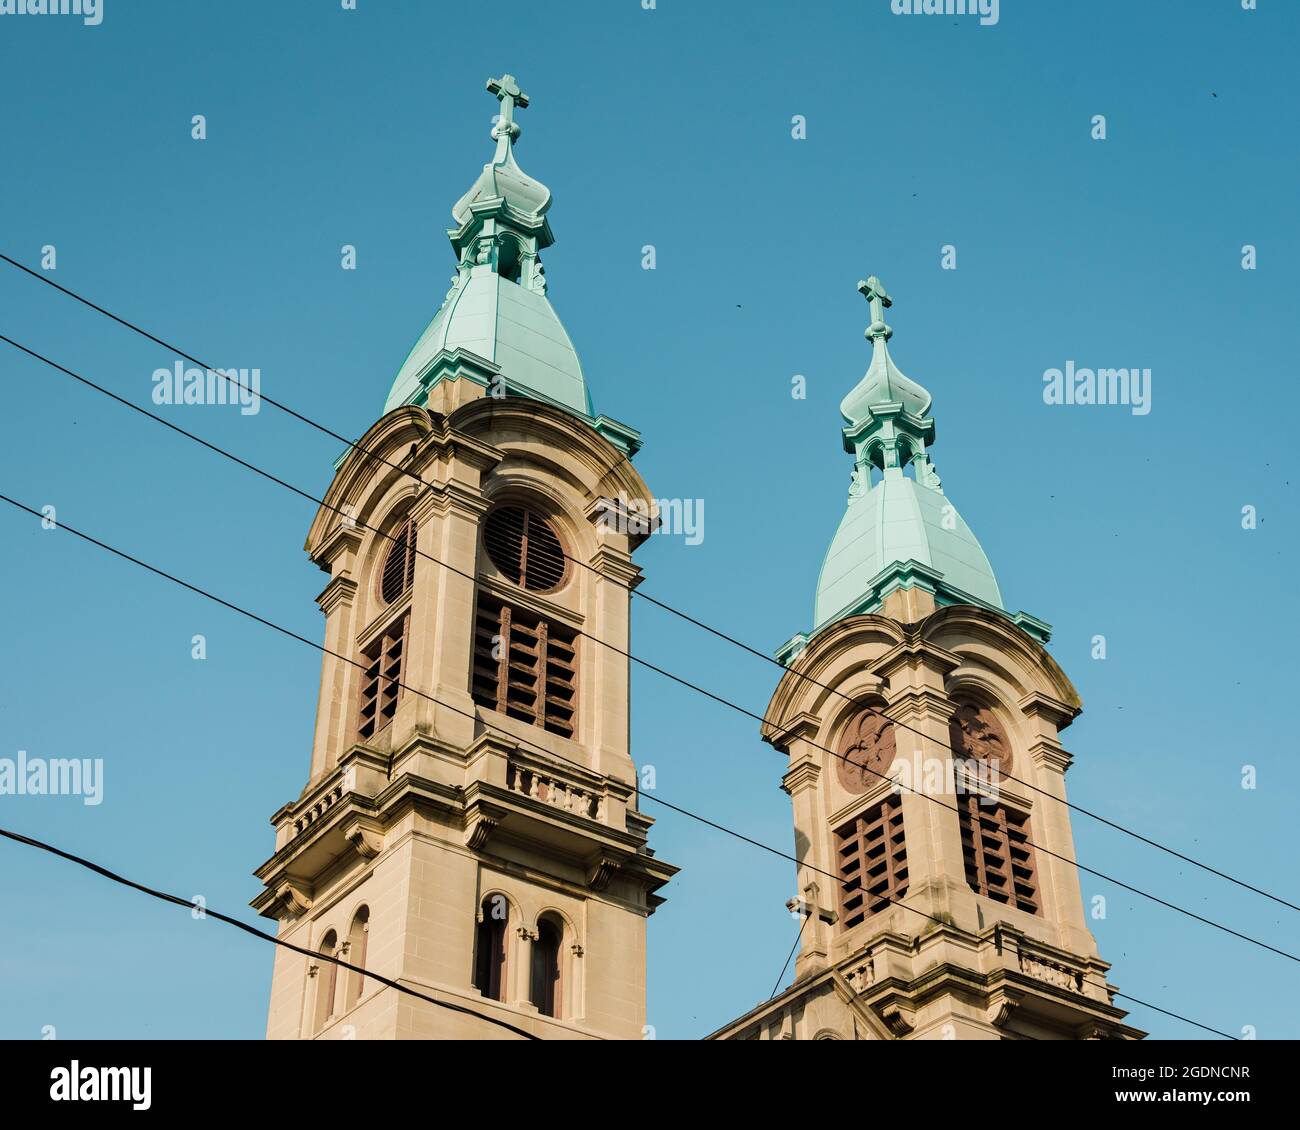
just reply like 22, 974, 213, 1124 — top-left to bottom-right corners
814, 278, 1002, 629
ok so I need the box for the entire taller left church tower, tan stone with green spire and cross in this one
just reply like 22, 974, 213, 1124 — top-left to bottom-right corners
252, 75, 676, 1039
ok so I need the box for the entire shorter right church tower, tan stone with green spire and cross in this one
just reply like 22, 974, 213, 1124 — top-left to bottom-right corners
715, 278, 1143, 1039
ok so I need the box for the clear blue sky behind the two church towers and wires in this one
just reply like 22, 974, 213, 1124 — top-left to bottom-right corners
0, 0, 1300, 1038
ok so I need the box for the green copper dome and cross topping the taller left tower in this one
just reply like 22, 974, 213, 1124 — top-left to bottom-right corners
384, 74, 592, 417
